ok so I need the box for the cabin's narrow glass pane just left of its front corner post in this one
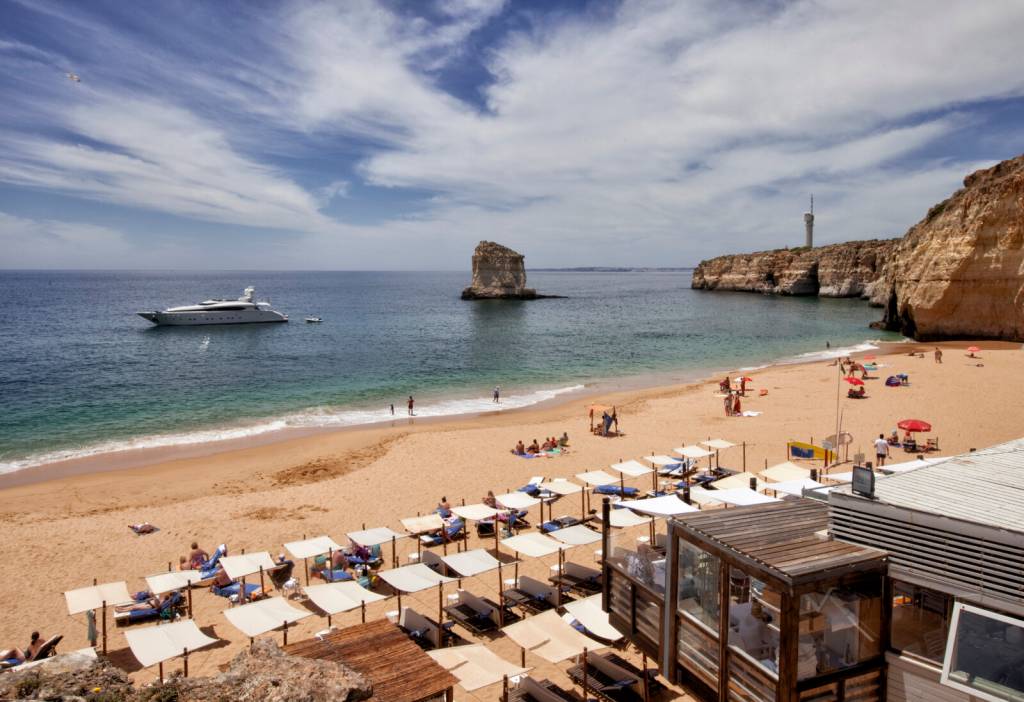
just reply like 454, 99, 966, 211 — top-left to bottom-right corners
729, 568, 782, 675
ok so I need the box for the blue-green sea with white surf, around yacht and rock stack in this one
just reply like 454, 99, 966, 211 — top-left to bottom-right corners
0, 271, 899, 473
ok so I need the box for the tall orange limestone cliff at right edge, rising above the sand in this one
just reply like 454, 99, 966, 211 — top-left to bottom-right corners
872, 156, 1024, 341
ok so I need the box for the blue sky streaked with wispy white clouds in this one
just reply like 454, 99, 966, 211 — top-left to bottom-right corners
0, 0, 1024, 270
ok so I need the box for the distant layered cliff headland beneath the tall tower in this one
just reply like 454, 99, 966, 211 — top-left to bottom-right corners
690, 239, 896, 298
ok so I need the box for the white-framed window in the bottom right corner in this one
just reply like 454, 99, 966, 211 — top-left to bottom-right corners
942, 603, 1024, 702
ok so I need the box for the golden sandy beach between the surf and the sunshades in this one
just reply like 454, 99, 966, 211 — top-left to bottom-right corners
0, 342, 1024, 699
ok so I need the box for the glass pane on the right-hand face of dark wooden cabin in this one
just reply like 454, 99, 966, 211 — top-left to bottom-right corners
797, 575, 882, 678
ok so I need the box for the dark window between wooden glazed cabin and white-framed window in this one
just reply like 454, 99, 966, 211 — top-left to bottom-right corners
891, 580, 953, 665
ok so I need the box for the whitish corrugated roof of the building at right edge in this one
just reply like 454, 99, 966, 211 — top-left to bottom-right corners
834, 439, 1024, 533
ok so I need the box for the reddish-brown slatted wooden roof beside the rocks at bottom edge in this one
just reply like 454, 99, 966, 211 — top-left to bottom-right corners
285, 619, 459, 702
